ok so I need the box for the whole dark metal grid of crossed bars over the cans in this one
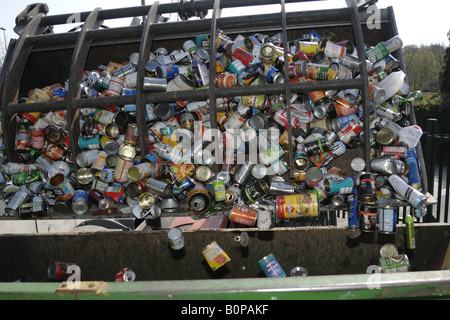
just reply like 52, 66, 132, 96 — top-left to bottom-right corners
2, 0, 370, 177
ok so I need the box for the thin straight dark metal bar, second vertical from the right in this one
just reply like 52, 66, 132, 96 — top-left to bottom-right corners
281, 0, 294, 181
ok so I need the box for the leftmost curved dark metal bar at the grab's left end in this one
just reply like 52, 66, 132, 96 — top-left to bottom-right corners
1, 14, 44, 161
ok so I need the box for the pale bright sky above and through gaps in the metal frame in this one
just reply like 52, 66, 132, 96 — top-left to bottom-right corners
0, 0, 450, 49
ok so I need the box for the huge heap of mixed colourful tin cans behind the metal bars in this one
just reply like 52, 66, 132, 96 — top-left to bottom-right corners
2, 26, 426, 242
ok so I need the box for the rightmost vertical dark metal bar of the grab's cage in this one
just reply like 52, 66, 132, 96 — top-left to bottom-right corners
351, 1, 371, 171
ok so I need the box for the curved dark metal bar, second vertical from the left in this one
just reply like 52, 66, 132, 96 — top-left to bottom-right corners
65, 8, 102, 169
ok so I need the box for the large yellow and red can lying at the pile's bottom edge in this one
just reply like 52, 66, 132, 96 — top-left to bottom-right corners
277, 193, 319, 219
